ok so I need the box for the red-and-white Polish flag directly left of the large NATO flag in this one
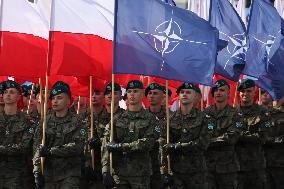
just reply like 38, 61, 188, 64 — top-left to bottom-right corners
49, 0, 114, 79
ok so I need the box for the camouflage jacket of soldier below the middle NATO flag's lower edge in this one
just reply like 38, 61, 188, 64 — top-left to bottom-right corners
204, 105, 241, 173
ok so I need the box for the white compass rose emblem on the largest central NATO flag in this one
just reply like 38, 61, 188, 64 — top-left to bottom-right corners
132, 10, 207, 71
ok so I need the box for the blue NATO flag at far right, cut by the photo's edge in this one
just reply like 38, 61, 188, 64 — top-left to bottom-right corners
243, 0, 284, 100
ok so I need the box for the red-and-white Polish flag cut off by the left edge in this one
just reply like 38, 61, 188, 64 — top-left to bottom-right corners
0, 0, 49, 77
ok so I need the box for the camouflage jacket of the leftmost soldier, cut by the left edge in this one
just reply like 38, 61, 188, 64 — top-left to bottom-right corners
0, 112, 34, 178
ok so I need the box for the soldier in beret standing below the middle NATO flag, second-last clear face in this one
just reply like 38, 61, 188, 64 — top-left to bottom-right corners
204, 79, 241, 189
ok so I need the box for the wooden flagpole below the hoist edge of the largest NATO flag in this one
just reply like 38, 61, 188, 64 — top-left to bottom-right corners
109, 74, 114, 175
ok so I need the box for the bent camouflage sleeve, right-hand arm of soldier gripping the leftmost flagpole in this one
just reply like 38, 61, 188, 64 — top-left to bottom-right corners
50, 124, 87, 157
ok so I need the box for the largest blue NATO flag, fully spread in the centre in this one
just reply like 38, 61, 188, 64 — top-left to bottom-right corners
113, 0, 218, 85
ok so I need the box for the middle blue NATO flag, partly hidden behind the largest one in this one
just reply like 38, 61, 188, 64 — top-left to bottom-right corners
209, 0, 247, 81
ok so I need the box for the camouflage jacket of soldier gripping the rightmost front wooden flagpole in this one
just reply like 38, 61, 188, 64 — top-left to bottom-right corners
161, 108, 209, 174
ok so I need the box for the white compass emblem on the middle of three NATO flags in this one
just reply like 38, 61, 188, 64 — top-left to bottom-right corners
219, 31, 248, 70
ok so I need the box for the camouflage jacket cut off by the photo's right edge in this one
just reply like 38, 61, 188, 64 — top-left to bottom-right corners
264, 106, 284, 167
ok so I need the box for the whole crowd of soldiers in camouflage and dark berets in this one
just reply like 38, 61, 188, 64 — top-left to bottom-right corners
0, 79, 284, 189
